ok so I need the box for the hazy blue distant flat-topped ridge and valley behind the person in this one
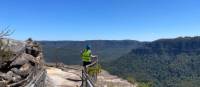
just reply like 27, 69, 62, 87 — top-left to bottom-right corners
39, 40, 143, 65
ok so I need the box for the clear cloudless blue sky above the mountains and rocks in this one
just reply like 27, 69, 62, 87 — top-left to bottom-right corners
0, 0, 200, 41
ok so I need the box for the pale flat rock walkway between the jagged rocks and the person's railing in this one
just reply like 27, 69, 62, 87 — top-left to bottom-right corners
47, 67, 81, 87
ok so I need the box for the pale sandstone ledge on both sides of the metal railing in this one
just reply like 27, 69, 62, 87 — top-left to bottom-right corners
46, 66, 137, 87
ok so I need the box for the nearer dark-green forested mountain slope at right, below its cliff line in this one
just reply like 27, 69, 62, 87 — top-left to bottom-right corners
106, 37, 200, 87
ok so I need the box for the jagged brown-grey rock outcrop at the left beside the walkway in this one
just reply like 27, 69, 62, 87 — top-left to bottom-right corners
0, 38, 45, 87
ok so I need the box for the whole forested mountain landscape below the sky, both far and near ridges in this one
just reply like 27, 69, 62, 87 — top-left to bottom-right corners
40, 37, 200, 87
